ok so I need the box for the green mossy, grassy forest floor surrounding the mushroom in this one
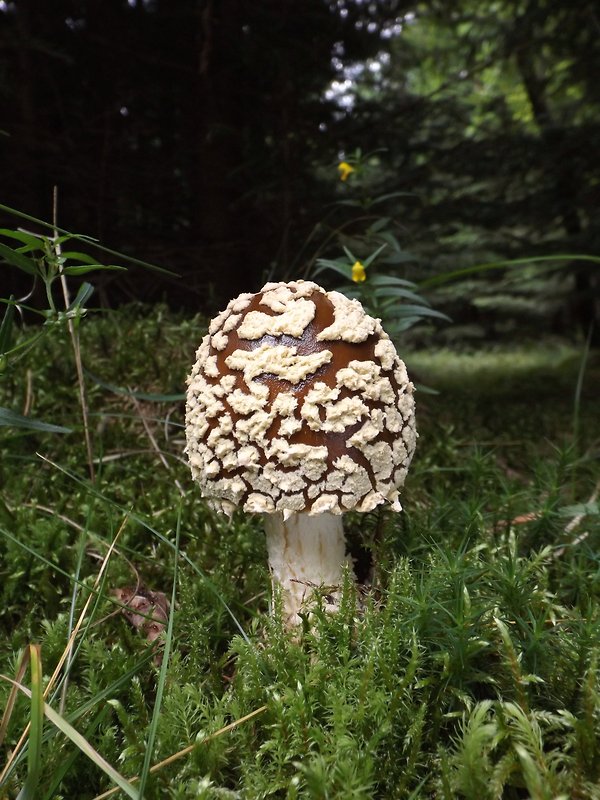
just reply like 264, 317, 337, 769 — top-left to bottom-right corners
0, 307, 600, 800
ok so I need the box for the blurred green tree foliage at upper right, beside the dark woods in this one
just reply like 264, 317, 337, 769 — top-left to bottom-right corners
343, 0, 600, 342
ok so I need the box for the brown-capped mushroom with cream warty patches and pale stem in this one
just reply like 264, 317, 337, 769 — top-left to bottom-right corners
186, 280, 417, 626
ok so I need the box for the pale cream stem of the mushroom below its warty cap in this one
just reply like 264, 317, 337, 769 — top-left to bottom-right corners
265, 513, 352, 627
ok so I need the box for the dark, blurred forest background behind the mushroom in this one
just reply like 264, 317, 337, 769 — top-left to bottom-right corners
0, 0, 600, 341
